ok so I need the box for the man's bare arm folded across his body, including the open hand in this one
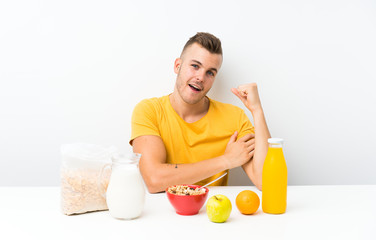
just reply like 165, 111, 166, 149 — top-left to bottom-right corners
132, 132, 254, 193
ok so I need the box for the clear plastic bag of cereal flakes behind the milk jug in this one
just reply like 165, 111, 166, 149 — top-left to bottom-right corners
60, 143, 117, 215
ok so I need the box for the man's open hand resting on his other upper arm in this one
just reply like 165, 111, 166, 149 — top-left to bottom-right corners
223, 132, 255, 169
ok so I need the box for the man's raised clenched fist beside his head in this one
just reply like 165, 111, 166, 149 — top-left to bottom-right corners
231, 83, 261, 113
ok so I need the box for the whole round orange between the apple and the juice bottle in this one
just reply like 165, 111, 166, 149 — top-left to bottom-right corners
236, 190, 260, 215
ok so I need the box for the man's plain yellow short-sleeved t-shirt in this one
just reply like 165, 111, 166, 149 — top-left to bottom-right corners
130, 96, 254, 186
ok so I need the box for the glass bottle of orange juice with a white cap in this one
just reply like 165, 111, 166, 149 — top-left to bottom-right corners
262, 138, 287, 214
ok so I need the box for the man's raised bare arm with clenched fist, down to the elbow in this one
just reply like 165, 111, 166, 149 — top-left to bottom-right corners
231, 83, 270, 190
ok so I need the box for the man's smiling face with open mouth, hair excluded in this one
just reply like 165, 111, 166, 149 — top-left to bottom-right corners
174, 43, 222, 104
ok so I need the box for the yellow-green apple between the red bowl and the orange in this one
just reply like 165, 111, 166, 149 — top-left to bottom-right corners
206, 194, 232, 223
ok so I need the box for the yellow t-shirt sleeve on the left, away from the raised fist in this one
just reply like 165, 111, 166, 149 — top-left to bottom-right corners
129, 99, 160, 145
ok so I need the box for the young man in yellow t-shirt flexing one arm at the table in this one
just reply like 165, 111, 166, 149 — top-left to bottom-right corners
130, 33, 270, 193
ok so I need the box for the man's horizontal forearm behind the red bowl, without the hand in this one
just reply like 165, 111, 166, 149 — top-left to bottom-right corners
140, 156, 227, 193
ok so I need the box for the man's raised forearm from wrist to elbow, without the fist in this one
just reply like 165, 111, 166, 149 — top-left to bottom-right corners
243, 107, 270, 190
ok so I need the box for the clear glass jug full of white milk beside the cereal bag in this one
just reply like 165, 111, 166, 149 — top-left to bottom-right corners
100, 153, 145, 219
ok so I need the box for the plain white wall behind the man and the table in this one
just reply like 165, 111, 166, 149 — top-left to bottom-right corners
0, 0, 376, 186
